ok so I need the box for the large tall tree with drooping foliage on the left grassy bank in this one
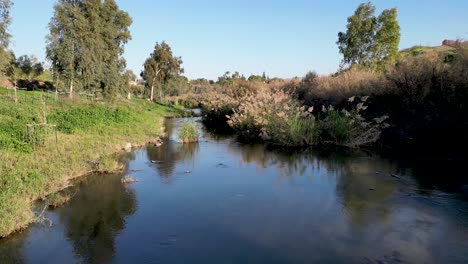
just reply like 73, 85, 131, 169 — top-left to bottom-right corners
47, 0, 132, 98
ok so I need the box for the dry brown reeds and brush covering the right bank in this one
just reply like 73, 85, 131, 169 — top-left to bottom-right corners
189, 44, 468, 150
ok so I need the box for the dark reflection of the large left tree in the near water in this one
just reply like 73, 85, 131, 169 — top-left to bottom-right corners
59, 175, 136, 263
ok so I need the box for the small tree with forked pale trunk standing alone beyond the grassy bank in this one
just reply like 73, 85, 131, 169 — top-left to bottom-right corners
141, 41, 184, 101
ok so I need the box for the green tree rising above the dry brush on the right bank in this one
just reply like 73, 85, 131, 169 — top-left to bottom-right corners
337, 2, 400, 68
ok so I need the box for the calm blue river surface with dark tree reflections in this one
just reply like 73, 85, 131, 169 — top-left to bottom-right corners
0, 119, 468, 264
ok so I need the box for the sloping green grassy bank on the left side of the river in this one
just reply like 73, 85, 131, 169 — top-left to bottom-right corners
0, 89, 179, 237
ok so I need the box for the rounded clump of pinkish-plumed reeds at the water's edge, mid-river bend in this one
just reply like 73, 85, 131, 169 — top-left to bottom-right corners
228, 85, 317, 146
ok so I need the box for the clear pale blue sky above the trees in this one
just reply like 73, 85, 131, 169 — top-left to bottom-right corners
10, 0, 468, 79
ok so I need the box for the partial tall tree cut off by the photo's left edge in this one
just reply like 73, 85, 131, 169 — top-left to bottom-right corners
0, 0, 13, 74
